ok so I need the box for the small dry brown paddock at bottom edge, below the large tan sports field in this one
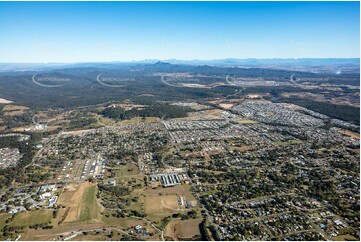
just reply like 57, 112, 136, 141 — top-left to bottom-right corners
164, 219, 202, 240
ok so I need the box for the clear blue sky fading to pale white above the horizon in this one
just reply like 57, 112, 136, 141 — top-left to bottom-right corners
0, 2, 360, 63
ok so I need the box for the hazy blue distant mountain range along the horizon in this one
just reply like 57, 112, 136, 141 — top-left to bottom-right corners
0, 58, 360, 73
